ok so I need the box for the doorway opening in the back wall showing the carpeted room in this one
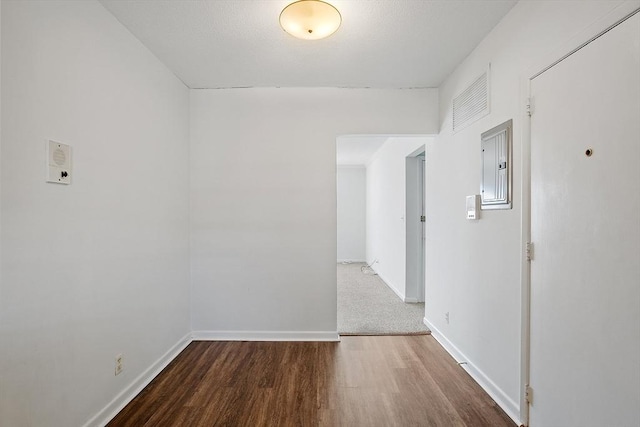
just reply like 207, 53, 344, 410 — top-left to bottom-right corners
336, 135, 430, 335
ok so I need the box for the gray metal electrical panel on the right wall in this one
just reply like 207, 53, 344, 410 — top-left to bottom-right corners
480, 120, 513, 209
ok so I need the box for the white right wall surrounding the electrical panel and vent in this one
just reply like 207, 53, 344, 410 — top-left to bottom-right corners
426, 1, 632, 419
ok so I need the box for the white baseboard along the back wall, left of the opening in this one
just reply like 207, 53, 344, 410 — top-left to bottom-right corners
191, 331, 340, 341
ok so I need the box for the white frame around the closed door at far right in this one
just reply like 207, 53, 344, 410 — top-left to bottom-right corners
520, 1, 640, 426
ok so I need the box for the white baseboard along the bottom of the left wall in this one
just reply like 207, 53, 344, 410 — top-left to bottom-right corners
84, 333, 191, 427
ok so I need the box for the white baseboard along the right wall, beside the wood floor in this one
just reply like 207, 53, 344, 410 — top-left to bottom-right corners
422, 317, 522, 425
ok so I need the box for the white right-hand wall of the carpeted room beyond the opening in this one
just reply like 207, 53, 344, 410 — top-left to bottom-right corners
367, 136, 429, 300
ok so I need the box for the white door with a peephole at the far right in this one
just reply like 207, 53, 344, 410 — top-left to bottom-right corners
529, 14, 640, 427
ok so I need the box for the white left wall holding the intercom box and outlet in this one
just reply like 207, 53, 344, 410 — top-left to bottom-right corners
0, 1, 189, 426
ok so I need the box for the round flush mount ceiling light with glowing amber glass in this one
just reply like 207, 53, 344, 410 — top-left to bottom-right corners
280, 0, 342, 40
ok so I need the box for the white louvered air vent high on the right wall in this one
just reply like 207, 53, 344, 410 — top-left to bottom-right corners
453, 68, 490, 132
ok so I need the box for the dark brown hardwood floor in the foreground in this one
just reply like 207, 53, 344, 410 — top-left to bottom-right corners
109, 335, 515, 427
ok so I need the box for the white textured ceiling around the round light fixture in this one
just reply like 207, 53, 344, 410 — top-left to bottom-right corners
101, 0, 516, 88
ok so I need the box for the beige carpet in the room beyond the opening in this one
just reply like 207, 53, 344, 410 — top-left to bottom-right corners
338, 263, 431, 335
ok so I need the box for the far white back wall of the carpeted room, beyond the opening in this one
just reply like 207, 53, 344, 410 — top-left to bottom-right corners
336, 166, 367, 262
